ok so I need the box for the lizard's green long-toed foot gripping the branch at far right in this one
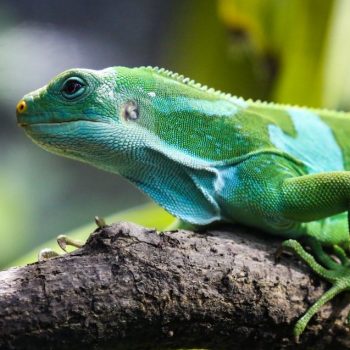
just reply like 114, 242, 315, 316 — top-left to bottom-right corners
282, 239, 350, 341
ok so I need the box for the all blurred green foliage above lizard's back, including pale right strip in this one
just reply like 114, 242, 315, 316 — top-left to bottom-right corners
166, 0, 350, 109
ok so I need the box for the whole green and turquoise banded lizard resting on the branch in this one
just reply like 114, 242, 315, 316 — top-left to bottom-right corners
17, 67, 350, 336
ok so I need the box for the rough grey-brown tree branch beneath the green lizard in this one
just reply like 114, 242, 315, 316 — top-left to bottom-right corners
0, 223, 350, 349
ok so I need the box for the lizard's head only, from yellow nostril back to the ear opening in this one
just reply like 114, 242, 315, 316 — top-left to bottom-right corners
16, 68, 145, 168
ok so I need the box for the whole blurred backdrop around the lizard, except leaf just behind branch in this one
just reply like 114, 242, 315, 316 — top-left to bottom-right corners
0, 0, 350, 267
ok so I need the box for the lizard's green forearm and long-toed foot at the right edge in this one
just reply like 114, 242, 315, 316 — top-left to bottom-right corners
282, 172, 350, 338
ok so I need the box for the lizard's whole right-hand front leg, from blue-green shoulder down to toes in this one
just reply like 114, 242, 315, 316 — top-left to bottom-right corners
220, 156, 350, 337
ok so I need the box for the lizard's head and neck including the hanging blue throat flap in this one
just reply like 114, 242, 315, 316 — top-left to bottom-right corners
17, 67, 242, 223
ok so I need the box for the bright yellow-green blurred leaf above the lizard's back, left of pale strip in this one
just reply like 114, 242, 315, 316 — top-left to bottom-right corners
219, 0, 333, 106
